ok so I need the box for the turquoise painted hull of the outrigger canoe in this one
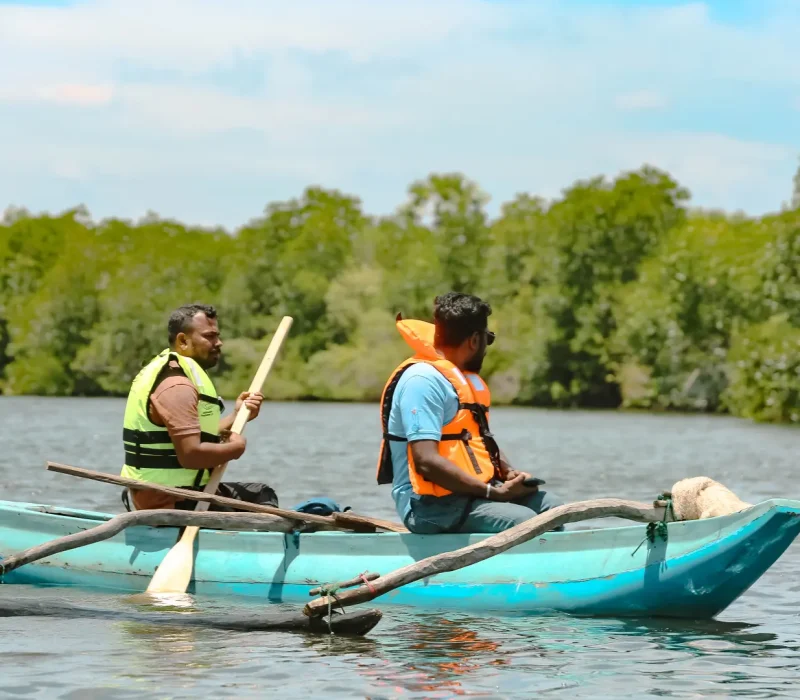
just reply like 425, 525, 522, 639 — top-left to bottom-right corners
0, 499, 800, 619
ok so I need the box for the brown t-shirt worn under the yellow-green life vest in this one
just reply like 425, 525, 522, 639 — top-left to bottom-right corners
131, 360, 200, 510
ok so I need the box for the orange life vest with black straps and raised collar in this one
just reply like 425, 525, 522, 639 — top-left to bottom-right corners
377, 315, 500, 496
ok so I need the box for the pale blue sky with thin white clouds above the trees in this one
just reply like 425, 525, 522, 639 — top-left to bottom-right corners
0, 0, 800, 230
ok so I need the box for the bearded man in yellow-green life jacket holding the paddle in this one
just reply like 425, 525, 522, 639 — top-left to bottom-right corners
122, 304, 278, 510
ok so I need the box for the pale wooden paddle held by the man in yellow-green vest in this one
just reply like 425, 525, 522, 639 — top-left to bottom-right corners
147, 316, 293, 593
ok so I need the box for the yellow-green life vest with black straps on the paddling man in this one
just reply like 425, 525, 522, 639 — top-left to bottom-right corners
121, 349, 223, 488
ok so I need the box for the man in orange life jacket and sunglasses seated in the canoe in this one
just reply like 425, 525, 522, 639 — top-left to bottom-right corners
378, 292, 562, 534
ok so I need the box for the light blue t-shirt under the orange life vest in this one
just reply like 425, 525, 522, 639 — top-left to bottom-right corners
389, 362, 458, 522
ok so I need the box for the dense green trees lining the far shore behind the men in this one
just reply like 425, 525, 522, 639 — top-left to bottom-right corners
0, 168, 800, 423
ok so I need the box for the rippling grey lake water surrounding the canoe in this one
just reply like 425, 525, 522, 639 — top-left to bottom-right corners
0, 397, 800, 700
